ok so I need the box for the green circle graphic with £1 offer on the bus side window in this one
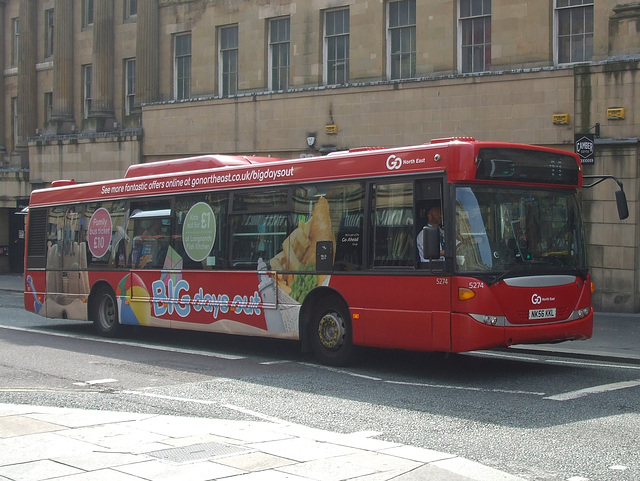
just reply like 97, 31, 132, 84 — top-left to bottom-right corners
182, 202, 216, 262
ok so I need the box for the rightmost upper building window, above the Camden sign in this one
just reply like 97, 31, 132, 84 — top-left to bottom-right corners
556, 0, 593, 63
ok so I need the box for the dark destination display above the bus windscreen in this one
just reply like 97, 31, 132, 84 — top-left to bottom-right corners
476, 148, 578, 185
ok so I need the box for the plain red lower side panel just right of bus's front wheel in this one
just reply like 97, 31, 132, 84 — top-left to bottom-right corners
330, 275, 451, 351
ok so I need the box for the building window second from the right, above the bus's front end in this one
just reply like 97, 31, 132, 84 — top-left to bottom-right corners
459, 0, 491, 73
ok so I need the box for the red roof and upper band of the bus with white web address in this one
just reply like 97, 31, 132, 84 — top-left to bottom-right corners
29, 137, 582, 207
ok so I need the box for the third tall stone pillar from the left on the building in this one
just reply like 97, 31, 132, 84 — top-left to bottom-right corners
85, 0, 116, 132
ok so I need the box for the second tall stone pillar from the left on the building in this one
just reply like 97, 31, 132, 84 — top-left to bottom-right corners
46, 0, 75, 134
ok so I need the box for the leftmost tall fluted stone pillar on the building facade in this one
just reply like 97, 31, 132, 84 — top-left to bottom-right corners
16, 0, 37, 168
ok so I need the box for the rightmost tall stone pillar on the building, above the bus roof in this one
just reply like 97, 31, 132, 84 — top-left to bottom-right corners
134, 0, 160, 113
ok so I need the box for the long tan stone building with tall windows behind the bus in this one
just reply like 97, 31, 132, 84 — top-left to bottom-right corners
0, 0, 640, 312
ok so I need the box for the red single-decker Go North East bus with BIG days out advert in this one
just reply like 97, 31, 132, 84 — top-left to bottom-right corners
24, 138, 624, 365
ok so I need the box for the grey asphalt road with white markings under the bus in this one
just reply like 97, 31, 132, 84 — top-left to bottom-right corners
0, 291, 640, 481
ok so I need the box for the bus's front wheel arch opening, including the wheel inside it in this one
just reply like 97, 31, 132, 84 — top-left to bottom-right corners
300, 287, 353, 366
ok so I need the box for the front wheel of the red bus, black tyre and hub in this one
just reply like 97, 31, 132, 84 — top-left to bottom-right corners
309, 299, 353, 366
